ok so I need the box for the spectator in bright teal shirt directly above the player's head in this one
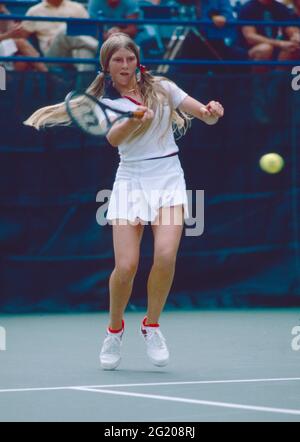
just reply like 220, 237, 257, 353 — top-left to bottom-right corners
88, 0, 156, 58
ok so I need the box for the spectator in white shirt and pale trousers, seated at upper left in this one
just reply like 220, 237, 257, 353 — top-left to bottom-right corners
4, 0, 98, 71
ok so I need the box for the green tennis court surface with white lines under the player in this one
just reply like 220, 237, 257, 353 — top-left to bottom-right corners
0, 309, 300, 422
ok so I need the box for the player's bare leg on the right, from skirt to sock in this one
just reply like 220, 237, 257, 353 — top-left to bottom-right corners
147, 205, 184, 324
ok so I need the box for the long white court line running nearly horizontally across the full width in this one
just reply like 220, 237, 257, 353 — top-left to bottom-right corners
0, 378, 300, 393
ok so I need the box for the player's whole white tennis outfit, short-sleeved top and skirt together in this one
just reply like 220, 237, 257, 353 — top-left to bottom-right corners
102, 80, 189, 222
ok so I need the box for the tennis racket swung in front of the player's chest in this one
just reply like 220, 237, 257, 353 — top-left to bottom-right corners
65, 91, 144, 136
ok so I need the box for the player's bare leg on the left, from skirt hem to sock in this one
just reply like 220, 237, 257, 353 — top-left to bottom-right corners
109, 219, 144, 330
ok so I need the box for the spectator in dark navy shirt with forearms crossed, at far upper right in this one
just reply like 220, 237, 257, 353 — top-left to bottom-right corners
238, 0, 300, 72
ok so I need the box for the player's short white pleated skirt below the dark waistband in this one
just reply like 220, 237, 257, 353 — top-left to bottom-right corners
106, 155, 189, 222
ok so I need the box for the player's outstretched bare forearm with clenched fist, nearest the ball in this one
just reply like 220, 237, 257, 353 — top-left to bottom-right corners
179, 96, 224, 125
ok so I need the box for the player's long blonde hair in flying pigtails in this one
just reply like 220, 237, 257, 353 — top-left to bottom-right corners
24, 33, 192, 141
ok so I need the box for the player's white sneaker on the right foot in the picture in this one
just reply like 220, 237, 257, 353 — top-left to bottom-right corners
141, 318, 170, 367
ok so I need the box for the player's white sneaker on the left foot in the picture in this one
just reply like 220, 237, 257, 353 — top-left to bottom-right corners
99, 325, 124, 370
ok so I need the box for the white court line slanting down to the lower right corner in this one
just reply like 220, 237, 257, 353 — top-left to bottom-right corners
75, 387, 300, 416
